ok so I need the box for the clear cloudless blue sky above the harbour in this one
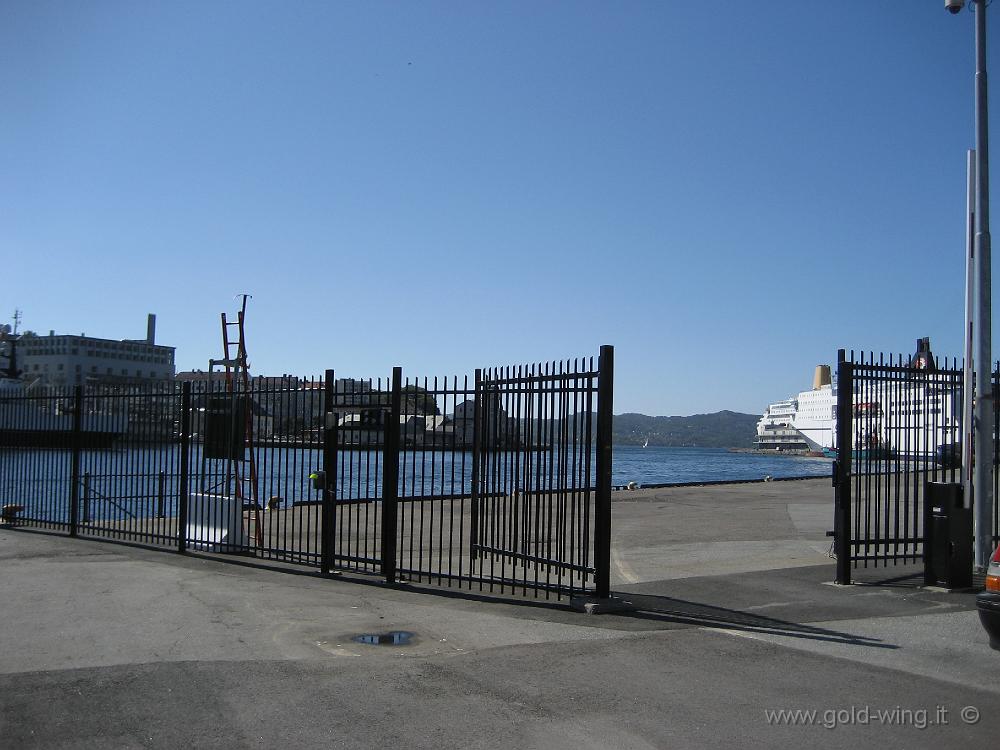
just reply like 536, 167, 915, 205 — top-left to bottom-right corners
0, 0, 1000, 415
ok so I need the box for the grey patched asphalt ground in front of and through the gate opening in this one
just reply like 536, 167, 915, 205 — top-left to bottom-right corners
0, 480, 1000, 750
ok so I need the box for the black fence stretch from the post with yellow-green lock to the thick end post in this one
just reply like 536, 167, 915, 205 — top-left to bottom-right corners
324, 347, 614, 596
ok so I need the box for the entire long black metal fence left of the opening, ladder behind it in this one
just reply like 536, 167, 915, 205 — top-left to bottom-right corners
0, 347, 614, 597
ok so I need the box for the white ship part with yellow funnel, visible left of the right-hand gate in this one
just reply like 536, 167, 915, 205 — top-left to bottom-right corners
756, 365, 837, 453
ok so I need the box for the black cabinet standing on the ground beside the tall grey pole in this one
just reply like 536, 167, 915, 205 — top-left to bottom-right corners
924, 482, 972, 589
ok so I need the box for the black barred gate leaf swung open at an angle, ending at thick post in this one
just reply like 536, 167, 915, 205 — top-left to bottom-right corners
471, 349, 611, 595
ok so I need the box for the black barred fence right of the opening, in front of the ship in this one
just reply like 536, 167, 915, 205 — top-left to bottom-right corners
834, 351, 1000, 583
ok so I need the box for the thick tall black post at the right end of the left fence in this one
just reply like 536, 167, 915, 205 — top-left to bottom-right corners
594, 345, 615, 599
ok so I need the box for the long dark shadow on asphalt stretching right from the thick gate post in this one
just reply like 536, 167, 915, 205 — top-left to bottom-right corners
622, 594, 899, 649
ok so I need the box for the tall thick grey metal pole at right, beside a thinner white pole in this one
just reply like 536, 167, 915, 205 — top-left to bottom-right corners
972, 0, 994, 570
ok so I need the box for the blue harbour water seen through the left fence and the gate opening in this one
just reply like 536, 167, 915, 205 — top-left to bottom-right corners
0, 444, 831, 520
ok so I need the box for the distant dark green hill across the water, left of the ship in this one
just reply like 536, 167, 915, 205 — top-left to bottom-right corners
613, 411, 760, 448
